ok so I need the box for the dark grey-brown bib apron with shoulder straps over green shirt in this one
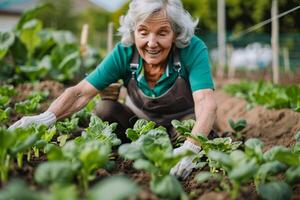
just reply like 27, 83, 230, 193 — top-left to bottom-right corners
127, 46, 194, 127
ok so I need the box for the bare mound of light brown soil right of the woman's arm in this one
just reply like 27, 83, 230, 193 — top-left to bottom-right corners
215, 87, 300, 150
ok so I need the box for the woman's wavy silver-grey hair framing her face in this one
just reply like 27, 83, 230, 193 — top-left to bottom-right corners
118, 0, 198, 48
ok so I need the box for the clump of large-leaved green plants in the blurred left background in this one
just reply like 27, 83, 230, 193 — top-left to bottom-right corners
0, 5, 100, 83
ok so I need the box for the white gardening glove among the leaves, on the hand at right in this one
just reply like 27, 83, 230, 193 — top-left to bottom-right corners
170, 140, 201, 179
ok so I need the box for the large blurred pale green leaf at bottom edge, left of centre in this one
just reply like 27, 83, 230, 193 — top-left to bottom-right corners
88, 176, 140, 200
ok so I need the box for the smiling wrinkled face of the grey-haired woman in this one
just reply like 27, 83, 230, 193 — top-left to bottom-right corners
134, 11, 175, 67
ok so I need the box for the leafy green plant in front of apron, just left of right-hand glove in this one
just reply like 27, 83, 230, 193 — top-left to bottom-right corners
119, 127, 192, 199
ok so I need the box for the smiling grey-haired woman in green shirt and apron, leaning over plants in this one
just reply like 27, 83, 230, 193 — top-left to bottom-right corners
10, 0, 217, 178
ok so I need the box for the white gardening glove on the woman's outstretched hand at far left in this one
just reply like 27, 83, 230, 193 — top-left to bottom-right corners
8, 111, 56, 131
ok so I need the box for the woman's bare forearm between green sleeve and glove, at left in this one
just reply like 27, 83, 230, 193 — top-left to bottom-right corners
47, 79, 99, 119
